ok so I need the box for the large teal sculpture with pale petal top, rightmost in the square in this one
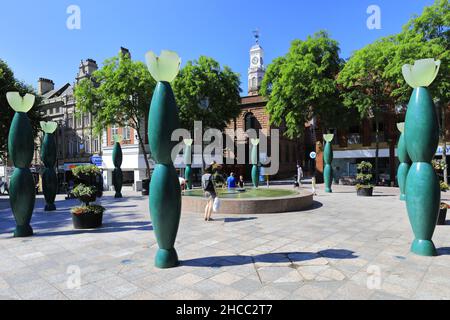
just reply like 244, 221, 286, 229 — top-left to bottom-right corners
403, 59, 441, 256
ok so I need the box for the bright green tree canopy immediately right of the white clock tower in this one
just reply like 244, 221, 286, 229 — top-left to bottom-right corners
261, 31, 343, 138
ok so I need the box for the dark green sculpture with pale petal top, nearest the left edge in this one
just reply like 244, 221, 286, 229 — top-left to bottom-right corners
6, 92, 36, 237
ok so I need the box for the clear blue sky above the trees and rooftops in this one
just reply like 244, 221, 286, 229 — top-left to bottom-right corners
0, 0, 434, 93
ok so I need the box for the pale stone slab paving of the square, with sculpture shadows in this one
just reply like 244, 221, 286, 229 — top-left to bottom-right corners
0, 186, 450, 300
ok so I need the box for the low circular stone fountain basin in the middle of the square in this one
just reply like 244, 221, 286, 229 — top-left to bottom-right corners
182, 188, 313, 214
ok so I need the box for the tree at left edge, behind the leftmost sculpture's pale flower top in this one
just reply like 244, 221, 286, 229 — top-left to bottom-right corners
0, 59, 41, 163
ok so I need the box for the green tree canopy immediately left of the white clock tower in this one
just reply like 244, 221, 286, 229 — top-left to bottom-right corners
173, 56, 241, 130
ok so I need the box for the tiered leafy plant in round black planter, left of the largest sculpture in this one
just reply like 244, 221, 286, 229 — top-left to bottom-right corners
71, 166, 105, 229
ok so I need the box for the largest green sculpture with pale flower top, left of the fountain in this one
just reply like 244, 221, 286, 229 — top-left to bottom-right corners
146, 51, 181, 268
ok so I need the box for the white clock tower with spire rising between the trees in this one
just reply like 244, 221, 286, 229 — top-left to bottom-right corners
248, 31, 266, 96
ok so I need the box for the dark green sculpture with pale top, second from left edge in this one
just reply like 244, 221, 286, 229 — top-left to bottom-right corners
41, 121, 58, 211
